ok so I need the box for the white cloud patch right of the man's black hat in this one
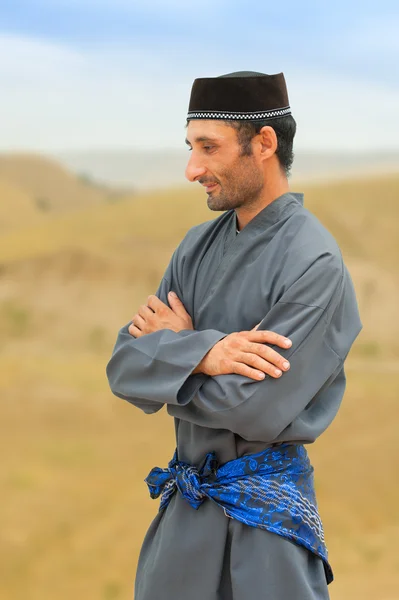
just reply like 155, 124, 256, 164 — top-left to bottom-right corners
287, 71, 399, 152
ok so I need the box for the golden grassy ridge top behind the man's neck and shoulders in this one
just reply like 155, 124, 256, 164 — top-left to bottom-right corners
0, 174, 399, 269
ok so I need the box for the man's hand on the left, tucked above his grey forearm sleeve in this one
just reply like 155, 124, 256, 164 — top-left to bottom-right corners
129, 292, 194, 338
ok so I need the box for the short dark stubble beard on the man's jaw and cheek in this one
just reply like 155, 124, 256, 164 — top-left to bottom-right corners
203, 157, 265, 211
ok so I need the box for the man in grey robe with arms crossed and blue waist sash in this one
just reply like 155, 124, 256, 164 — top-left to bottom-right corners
107, 72, 361, 600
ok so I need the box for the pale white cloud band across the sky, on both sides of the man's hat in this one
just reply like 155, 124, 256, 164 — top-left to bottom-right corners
0, 35, 399, 151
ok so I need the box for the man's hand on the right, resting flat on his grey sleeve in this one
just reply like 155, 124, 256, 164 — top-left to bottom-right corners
193, 327, 292, 381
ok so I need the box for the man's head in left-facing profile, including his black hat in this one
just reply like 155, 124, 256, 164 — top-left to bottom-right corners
186, 72, 296, 210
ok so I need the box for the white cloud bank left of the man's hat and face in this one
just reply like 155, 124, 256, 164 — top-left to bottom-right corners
0, 36, 188, 150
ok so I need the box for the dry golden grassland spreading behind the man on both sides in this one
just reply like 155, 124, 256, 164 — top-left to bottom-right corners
0, 165, 399, 600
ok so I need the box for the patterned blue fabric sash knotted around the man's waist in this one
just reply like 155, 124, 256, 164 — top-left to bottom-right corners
145, 443, 333, 583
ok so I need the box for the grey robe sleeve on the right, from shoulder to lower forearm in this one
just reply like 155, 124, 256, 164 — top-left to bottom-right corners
168, 254, 361, 442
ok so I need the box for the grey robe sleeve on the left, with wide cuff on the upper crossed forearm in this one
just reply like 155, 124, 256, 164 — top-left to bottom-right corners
106, 250, 227, 414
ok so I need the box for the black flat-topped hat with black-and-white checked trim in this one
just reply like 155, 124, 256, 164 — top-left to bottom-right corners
187, 71, 291, 121
